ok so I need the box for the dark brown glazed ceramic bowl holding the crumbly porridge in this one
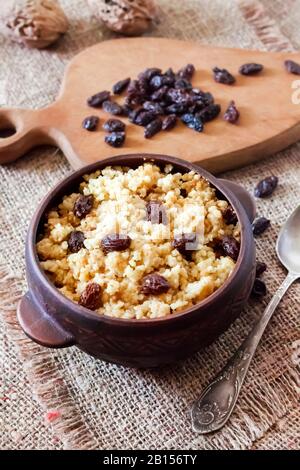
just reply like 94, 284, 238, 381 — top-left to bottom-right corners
18, 154, 255, 367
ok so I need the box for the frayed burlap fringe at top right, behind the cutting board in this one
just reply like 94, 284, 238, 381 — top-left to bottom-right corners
239, 0, 294, 52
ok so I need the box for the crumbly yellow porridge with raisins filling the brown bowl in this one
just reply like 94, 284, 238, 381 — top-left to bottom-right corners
37, 163, 240, 319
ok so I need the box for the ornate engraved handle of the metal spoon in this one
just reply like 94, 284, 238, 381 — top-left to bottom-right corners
191, 273, 299, 434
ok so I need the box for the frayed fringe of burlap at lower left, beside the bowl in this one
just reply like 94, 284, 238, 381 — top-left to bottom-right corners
0, 265, 97, 449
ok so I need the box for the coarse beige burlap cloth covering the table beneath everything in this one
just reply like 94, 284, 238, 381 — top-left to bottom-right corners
0, 0, 300, 449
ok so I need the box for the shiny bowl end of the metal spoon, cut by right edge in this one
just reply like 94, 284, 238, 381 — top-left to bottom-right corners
276, 205, 300, 275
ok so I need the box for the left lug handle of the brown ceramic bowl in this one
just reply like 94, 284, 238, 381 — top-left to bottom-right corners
17, 292, 75, 348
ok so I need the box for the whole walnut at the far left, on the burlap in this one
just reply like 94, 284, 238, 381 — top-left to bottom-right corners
3, 0, 69, 49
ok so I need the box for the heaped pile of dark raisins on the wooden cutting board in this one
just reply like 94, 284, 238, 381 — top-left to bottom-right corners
87, 64, 226, 147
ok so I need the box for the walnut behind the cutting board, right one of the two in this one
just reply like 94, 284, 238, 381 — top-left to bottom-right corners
88, 0, 157, 36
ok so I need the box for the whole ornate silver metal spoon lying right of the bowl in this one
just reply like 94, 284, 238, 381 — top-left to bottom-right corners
191, 206, 300, 434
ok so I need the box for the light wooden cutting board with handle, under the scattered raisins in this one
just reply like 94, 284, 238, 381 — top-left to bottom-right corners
0, 38, 300, 173
